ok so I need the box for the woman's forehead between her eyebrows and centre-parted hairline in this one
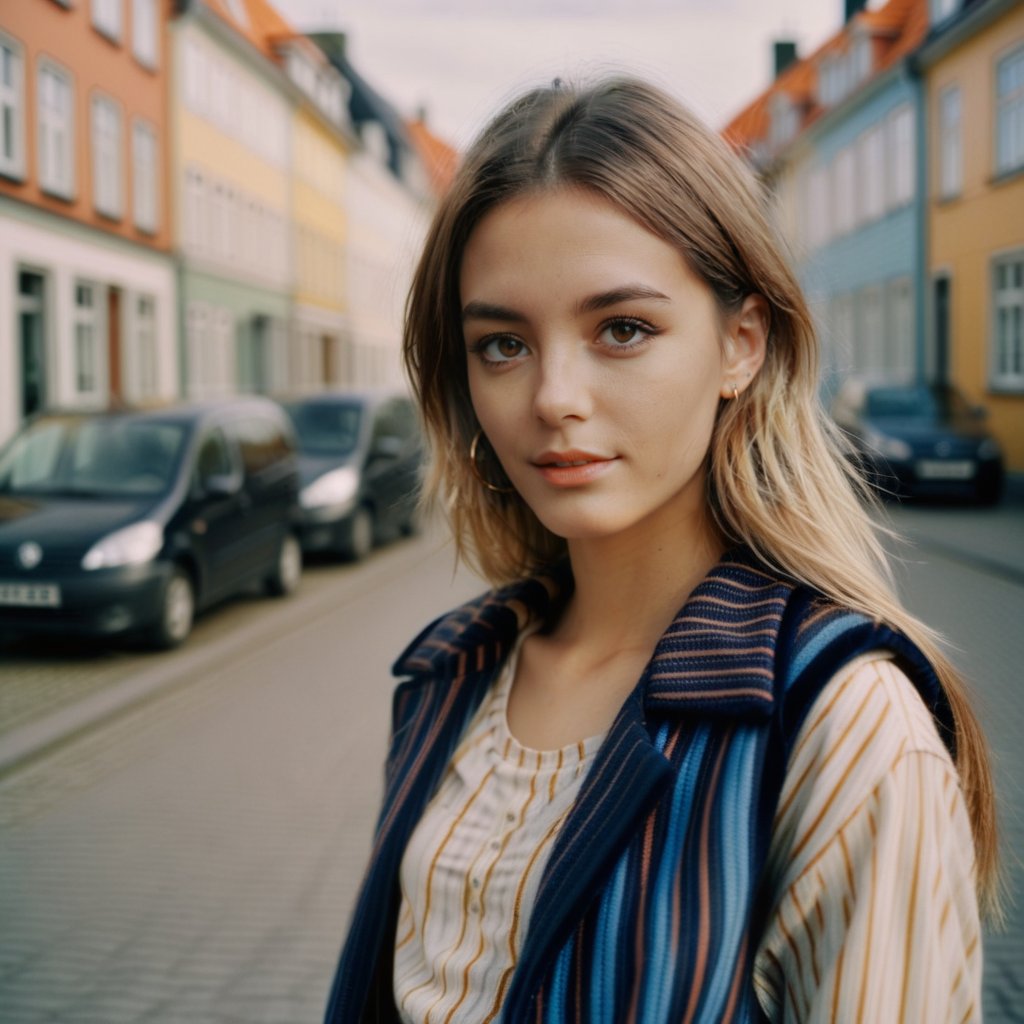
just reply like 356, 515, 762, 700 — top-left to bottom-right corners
460, 188, 700, 304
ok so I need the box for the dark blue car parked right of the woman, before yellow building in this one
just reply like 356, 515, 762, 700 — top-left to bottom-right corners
833, 378, 1004, 504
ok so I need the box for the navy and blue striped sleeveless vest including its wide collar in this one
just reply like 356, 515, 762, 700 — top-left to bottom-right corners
326, 550, 952, 1024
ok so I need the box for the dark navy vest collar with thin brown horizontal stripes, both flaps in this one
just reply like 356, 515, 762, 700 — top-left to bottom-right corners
393, 548, 793, 719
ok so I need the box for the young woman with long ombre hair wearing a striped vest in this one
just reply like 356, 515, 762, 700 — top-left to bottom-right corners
328, 80, 996, 1024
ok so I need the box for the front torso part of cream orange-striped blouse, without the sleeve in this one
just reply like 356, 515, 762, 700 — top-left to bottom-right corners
394, 637, 604, 1024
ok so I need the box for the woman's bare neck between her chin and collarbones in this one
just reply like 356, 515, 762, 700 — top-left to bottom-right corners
556, 508, 725, 653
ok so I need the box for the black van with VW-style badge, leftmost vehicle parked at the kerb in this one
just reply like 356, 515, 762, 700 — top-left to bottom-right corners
0, 397, 302, 647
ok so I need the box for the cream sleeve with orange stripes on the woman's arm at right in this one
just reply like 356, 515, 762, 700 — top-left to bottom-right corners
754, 654, 981, 1024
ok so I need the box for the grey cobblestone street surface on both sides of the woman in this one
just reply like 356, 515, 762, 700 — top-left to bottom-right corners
0, 504, 1024, 1024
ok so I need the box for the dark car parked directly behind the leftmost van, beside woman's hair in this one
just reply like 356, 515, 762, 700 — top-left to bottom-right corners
283, 391, 423, 561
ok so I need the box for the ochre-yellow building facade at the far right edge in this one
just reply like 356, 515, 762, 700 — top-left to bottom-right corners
921, 0, 1024, 473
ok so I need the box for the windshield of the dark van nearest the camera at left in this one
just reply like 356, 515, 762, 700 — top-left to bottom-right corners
0, 416, 185, 498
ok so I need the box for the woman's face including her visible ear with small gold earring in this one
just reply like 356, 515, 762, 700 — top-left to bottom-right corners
461, 188, 764, 541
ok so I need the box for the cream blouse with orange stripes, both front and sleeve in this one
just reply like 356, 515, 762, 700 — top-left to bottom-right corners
394, 654, 981, 1024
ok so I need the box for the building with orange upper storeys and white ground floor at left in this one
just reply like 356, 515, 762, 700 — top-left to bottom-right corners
0, 0, 178, 438
